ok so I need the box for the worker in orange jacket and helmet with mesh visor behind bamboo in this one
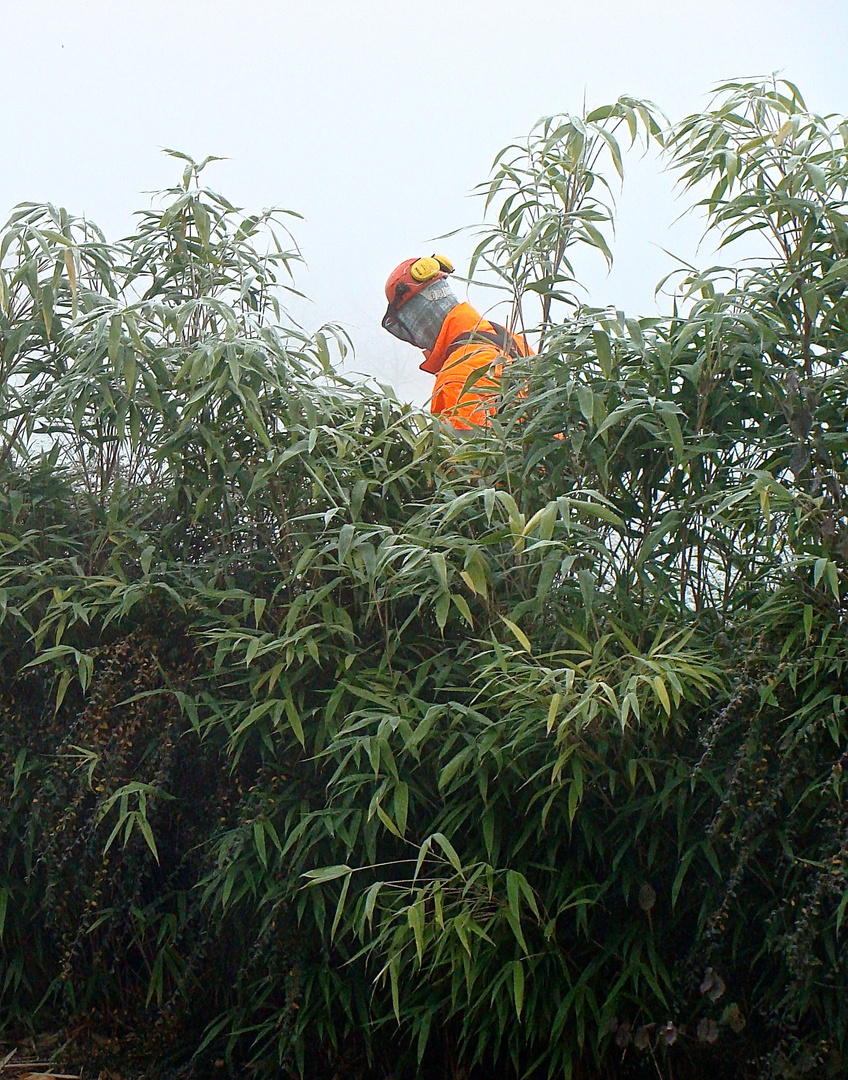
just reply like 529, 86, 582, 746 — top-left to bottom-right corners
382, 255, 530, 429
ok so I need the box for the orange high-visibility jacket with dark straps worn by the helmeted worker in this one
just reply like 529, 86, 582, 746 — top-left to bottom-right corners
421, 303, 531, 428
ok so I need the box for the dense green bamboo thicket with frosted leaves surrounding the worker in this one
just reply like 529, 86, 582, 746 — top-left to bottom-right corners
0, 83, 848, 1077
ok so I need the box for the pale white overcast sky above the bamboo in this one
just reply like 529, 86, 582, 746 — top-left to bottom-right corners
0, 0, 848, 403
